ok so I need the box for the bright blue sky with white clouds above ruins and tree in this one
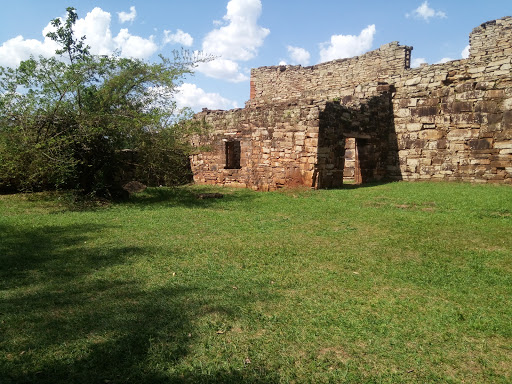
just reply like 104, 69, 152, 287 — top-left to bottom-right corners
0, 0, 512, 110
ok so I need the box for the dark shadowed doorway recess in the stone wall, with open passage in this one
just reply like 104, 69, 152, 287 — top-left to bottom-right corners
312, 85, 401, 188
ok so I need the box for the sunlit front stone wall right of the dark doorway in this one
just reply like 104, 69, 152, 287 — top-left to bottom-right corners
393, 57, 512, 183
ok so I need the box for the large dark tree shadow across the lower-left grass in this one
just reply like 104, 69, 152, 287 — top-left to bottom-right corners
0, 220, 278, 384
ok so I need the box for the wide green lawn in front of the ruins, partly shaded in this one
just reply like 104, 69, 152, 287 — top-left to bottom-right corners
0, 183, 512, 384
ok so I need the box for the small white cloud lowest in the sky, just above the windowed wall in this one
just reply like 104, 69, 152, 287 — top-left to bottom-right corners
175, 83, 238, 111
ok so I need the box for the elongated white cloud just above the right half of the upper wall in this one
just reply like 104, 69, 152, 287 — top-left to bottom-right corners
320, 24, 375, 62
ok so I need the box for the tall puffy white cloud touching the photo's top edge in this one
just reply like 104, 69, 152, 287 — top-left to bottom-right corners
203, 0, 270, 61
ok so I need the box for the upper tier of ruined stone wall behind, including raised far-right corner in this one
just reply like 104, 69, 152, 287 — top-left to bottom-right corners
246, 16, 512, 107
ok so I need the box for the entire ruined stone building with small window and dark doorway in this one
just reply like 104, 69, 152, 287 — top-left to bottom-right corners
191, 17, 512, 191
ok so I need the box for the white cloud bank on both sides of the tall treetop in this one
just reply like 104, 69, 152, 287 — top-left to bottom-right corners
0, 7, 158, 67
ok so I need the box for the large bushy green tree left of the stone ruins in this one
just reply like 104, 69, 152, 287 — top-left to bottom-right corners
0, 8, 210, 195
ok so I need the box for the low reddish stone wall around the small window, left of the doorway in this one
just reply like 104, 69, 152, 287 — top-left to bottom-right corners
191, 104, 319, 190
